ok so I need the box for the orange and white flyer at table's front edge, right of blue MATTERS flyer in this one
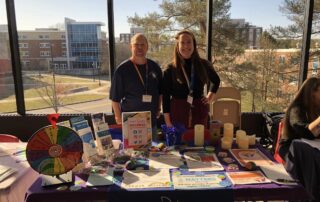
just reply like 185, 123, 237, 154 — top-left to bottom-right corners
227, 171, 271, 184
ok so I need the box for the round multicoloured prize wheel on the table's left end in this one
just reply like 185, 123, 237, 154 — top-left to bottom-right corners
26, 125, 83, 176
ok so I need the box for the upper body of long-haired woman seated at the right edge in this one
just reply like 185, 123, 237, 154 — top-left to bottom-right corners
279, 77, 320, 160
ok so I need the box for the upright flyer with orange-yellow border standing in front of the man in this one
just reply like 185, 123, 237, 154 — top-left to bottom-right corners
122, 111, 152, 149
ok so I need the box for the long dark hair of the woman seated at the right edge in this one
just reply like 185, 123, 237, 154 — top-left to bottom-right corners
283, 77, 320, 138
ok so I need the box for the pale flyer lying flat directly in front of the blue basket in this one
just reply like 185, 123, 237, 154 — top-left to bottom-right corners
149, 151, 184, 169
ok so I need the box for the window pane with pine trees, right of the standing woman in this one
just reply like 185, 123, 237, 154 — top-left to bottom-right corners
212, 0, 304, 112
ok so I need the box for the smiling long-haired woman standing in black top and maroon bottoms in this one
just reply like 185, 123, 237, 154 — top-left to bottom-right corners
162, 30, 220, 128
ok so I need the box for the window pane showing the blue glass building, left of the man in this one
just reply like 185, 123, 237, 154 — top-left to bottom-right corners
10, 0, 111, 113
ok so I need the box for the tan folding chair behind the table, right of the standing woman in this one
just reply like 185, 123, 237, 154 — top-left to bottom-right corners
210, 87, 241, 129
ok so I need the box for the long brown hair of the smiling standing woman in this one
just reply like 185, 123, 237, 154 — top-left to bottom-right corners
172, 30, 209, 84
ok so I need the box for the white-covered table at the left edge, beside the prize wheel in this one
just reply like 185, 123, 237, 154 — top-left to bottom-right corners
0, 143, 39, 202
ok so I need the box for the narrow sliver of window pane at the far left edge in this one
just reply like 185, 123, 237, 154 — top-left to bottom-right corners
0, 0, 17, 113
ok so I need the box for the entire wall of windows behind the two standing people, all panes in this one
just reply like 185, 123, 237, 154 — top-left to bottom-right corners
0, 0, 320, 113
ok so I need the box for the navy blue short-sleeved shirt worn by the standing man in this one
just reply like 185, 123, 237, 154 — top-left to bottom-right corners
109, 59, 162, 126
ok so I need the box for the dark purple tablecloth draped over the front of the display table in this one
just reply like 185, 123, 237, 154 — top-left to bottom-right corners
25, 143, 310, 202
